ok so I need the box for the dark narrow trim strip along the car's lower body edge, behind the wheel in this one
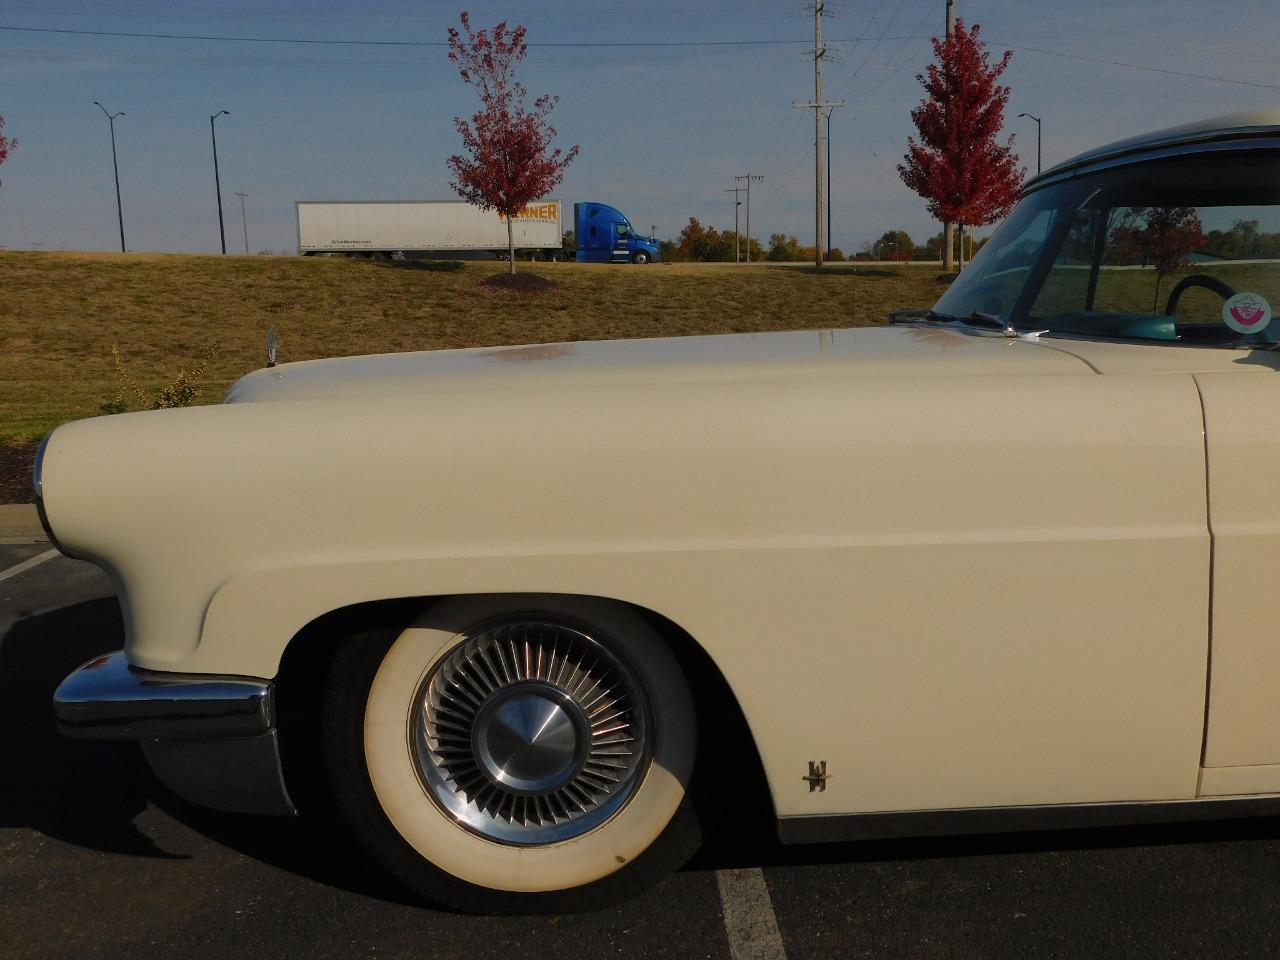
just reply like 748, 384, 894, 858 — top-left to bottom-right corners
778, 795, 1280, 844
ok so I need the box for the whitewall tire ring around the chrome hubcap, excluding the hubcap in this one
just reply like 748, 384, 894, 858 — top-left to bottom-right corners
325, 595, 700, 911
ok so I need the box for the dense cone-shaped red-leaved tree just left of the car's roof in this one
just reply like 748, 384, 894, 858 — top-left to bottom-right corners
897, 19, 1027, 267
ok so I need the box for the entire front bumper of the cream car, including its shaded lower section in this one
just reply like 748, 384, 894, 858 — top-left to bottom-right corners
54, 652, 296, 815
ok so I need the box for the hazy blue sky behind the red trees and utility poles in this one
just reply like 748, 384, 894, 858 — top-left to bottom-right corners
0, 0, 1280, 252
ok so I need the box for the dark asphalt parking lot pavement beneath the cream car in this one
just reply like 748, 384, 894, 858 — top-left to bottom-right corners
0, 543, 1280, 960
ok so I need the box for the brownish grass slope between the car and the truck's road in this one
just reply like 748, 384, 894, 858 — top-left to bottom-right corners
0, 252, 943, 443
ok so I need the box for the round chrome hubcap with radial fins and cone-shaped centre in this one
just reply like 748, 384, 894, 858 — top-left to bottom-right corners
411, 620, 652, 846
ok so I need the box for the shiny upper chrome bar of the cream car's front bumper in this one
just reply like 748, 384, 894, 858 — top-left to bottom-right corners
54, 652, 275, 740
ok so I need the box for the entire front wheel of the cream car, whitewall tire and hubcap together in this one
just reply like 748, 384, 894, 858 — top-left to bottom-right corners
324, 595, 701, 913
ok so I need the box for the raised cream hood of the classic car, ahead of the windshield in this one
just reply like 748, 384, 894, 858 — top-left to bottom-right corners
227, 325, 1093, 403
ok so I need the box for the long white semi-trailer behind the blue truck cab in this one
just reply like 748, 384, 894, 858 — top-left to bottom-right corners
294, 200, 572, 260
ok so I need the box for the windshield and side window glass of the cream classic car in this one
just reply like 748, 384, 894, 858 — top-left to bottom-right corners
934, 152, 1280, 346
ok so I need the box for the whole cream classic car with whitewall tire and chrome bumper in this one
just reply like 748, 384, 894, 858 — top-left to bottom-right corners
45, 111, 1280, 910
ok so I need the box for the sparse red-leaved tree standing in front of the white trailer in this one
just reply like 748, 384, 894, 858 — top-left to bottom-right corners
448, 10, 577, 273
